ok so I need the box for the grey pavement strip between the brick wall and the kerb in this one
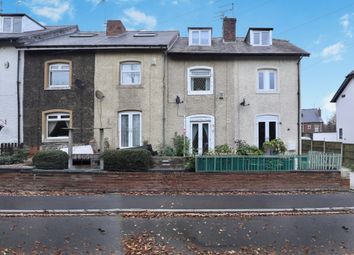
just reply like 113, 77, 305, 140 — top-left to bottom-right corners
0, 192, 354, 211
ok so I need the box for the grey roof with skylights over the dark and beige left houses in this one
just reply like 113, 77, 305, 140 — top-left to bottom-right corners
19, 31, 178, 49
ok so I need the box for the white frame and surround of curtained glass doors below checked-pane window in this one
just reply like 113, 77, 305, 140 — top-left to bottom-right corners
184, 114, 215, 153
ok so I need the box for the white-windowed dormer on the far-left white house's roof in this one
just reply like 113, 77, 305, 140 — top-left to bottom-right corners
0, 13, 45, 33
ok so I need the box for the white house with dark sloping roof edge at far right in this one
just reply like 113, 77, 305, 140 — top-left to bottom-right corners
331, 71, 354, 143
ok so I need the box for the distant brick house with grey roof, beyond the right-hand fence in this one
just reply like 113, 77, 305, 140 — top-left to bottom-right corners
301, 108, 323, 139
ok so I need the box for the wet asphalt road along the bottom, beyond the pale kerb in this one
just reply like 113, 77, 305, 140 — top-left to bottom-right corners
0, 214, 354, 255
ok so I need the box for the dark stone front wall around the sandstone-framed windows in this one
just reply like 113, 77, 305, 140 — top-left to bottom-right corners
23, 51, 95, 147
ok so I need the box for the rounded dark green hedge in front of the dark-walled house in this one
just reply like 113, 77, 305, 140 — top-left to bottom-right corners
32, 150, 69, 169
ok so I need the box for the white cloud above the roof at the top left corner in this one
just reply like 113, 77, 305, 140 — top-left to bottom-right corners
24, 0, 74, 22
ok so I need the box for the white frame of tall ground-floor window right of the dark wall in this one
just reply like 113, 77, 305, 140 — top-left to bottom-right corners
118, 111, 142, 149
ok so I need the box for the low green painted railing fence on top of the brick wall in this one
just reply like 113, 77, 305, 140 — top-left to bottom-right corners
195, 152, 341, 172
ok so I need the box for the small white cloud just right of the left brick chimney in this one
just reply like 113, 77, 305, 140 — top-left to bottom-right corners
123, 7, 157, 30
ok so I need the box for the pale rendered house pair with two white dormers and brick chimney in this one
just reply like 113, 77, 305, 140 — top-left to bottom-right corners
165, 18, 309, 154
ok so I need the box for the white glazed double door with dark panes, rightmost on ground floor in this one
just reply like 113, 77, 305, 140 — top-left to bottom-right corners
256, 115, 279, 148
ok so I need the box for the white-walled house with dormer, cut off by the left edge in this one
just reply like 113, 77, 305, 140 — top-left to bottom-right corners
0, 13, 77, 144
